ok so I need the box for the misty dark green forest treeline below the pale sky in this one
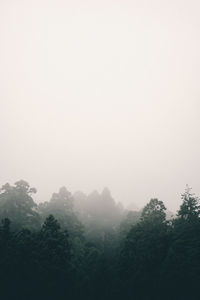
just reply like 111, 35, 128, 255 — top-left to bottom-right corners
0, 180, 200, 300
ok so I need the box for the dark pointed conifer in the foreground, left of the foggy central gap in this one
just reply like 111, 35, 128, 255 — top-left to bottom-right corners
37, 215, 73, 299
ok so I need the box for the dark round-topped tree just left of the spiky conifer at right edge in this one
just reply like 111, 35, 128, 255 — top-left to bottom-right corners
120, 199, 169, 299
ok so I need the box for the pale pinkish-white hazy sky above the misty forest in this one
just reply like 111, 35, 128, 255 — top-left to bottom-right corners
0, 0, 200, 210
